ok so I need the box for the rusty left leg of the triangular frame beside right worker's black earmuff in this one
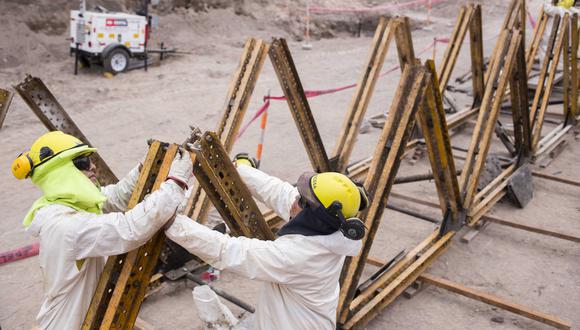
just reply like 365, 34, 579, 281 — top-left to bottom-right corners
338, 65, 427, 323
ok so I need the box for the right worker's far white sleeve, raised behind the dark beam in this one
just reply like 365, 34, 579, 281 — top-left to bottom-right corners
238, 165, 299, 221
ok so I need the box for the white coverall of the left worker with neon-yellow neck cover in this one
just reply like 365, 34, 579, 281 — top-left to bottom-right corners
27, 167, 184, 330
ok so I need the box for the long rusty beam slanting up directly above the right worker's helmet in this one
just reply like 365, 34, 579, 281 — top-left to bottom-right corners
333, 17, 395, 172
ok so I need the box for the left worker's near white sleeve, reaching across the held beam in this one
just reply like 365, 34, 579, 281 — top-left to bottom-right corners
70, 180, 183, 260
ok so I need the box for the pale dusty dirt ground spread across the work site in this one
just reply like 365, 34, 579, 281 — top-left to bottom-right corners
0, 1, 580, 329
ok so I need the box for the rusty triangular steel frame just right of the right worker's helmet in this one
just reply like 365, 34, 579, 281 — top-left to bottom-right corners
337, 62, 463, 329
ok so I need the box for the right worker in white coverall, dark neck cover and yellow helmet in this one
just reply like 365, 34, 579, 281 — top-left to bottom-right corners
165, 155, 368, 330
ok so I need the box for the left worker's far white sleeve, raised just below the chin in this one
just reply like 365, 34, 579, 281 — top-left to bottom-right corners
101, 165, 139, 213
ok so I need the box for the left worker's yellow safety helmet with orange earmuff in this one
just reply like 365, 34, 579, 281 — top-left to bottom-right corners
12, 131, 90, 180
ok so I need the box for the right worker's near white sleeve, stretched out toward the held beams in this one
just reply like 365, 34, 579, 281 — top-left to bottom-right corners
165, 215, 295, 283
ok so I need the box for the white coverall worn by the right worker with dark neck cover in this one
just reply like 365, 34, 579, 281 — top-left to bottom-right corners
165, 165, 361, 330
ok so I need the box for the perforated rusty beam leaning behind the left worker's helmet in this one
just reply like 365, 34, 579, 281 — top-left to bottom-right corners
14, 75, 119, 185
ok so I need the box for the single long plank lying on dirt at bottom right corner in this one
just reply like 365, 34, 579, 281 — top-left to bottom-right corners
419, 273, 572, 329
